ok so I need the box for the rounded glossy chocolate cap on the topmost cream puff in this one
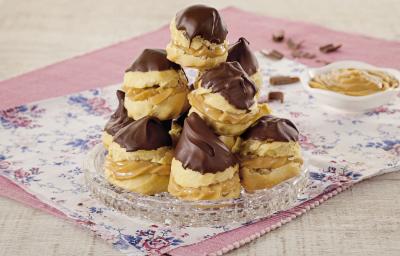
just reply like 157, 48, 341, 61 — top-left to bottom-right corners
175, 5, 228, 44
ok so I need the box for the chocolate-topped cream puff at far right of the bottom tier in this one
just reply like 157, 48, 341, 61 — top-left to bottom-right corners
240, 115, 303, 192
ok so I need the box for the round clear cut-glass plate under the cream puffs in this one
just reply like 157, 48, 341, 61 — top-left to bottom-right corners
83, 144, 308, 226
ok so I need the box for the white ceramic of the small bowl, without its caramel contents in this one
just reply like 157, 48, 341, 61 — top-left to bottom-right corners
300, 61, 400, 112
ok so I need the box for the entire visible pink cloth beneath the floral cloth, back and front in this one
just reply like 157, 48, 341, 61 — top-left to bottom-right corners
0, 7, 400, 255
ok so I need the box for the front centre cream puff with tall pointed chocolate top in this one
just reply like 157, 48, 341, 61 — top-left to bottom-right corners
168, 113, 241, 200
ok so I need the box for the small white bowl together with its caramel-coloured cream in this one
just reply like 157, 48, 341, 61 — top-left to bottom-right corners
301, 61, 400, 112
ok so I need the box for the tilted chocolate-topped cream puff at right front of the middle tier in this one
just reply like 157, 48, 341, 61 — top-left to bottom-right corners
188, 62, 270, 136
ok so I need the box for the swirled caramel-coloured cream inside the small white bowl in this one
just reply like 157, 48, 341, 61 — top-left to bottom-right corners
309, 68, 399, 96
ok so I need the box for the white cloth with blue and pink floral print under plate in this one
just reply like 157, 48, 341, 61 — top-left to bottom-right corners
0, 56, 400, 255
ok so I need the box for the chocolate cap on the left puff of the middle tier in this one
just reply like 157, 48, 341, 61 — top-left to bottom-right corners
125, 49, 181, 72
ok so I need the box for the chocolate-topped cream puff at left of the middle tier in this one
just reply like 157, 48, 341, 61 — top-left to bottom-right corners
122, 49, 189, 120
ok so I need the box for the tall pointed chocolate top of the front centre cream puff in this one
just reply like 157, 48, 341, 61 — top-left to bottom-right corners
175, 113, 237, 174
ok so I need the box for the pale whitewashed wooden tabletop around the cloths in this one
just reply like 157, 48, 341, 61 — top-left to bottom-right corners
0, 0, 400, 256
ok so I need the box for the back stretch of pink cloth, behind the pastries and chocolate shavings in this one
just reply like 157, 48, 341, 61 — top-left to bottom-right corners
0, 7, 400, 109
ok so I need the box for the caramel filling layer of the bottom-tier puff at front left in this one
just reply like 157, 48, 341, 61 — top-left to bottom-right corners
104, 156, 171, 180
